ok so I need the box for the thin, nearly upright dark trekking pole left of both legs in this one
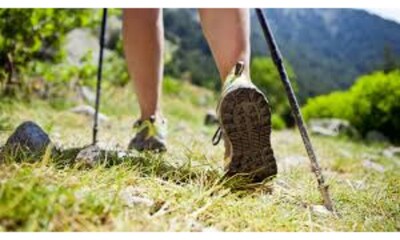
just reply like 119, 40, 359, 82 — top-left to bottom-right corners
92, 8, 107, 145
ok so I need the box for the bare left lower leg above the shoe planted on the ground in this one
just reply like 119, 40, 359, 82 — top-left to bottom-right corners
123, 9, 164, 119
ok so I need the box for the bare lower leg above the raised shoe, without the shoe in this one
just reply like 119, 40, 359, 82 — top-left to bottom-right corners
199, 8, 250, 80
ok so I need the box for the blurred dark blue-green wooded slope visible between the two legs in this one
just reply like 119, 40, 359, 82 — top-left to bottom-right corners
164, 9, 220, 89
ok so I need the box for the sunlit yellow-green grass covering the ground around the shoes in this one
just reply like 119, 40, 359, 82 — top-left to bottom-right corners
0, 81, 400, 231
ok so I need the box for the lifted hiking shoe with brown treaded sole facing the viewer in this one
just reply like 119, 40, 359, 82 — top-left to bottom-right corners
213, 62, 277, 182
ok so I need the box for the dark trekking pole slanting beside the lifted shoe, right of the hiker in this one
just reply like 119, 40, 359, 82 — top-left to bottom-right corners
256, 8, 334, 211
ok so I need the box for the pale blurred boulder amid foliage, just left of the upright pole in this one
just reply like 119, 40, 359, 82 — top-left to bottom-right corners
65, 28, 100, 66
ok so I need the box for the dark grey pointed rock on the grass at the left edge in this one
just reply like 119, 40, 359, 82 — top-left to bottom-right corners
4, 121, 51, 153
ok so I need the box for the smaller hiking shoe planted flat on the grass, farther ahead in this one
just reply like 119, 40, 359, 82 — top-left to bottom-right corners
128, 116, 167, 152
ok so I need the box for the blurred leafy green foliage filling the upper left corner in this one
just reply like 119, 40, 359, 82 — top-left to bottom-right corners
0, 9, 97, 95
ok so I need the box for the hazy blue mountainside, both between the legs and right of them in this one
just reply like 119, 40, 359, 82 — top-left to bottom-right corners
164, 9, 400, 102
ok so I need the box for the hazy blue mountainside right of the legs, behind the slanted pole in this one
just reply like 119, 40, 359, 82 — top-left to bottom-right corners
252, 9, 400, 99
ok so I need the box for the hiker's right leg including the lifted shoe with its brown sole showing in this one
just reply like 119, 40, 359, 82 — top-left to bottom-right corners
199, 9, 277, 182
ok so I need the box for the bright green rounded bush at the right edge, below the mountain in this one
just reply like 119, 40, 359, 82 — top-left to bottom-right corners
303, 71, 400, 142
